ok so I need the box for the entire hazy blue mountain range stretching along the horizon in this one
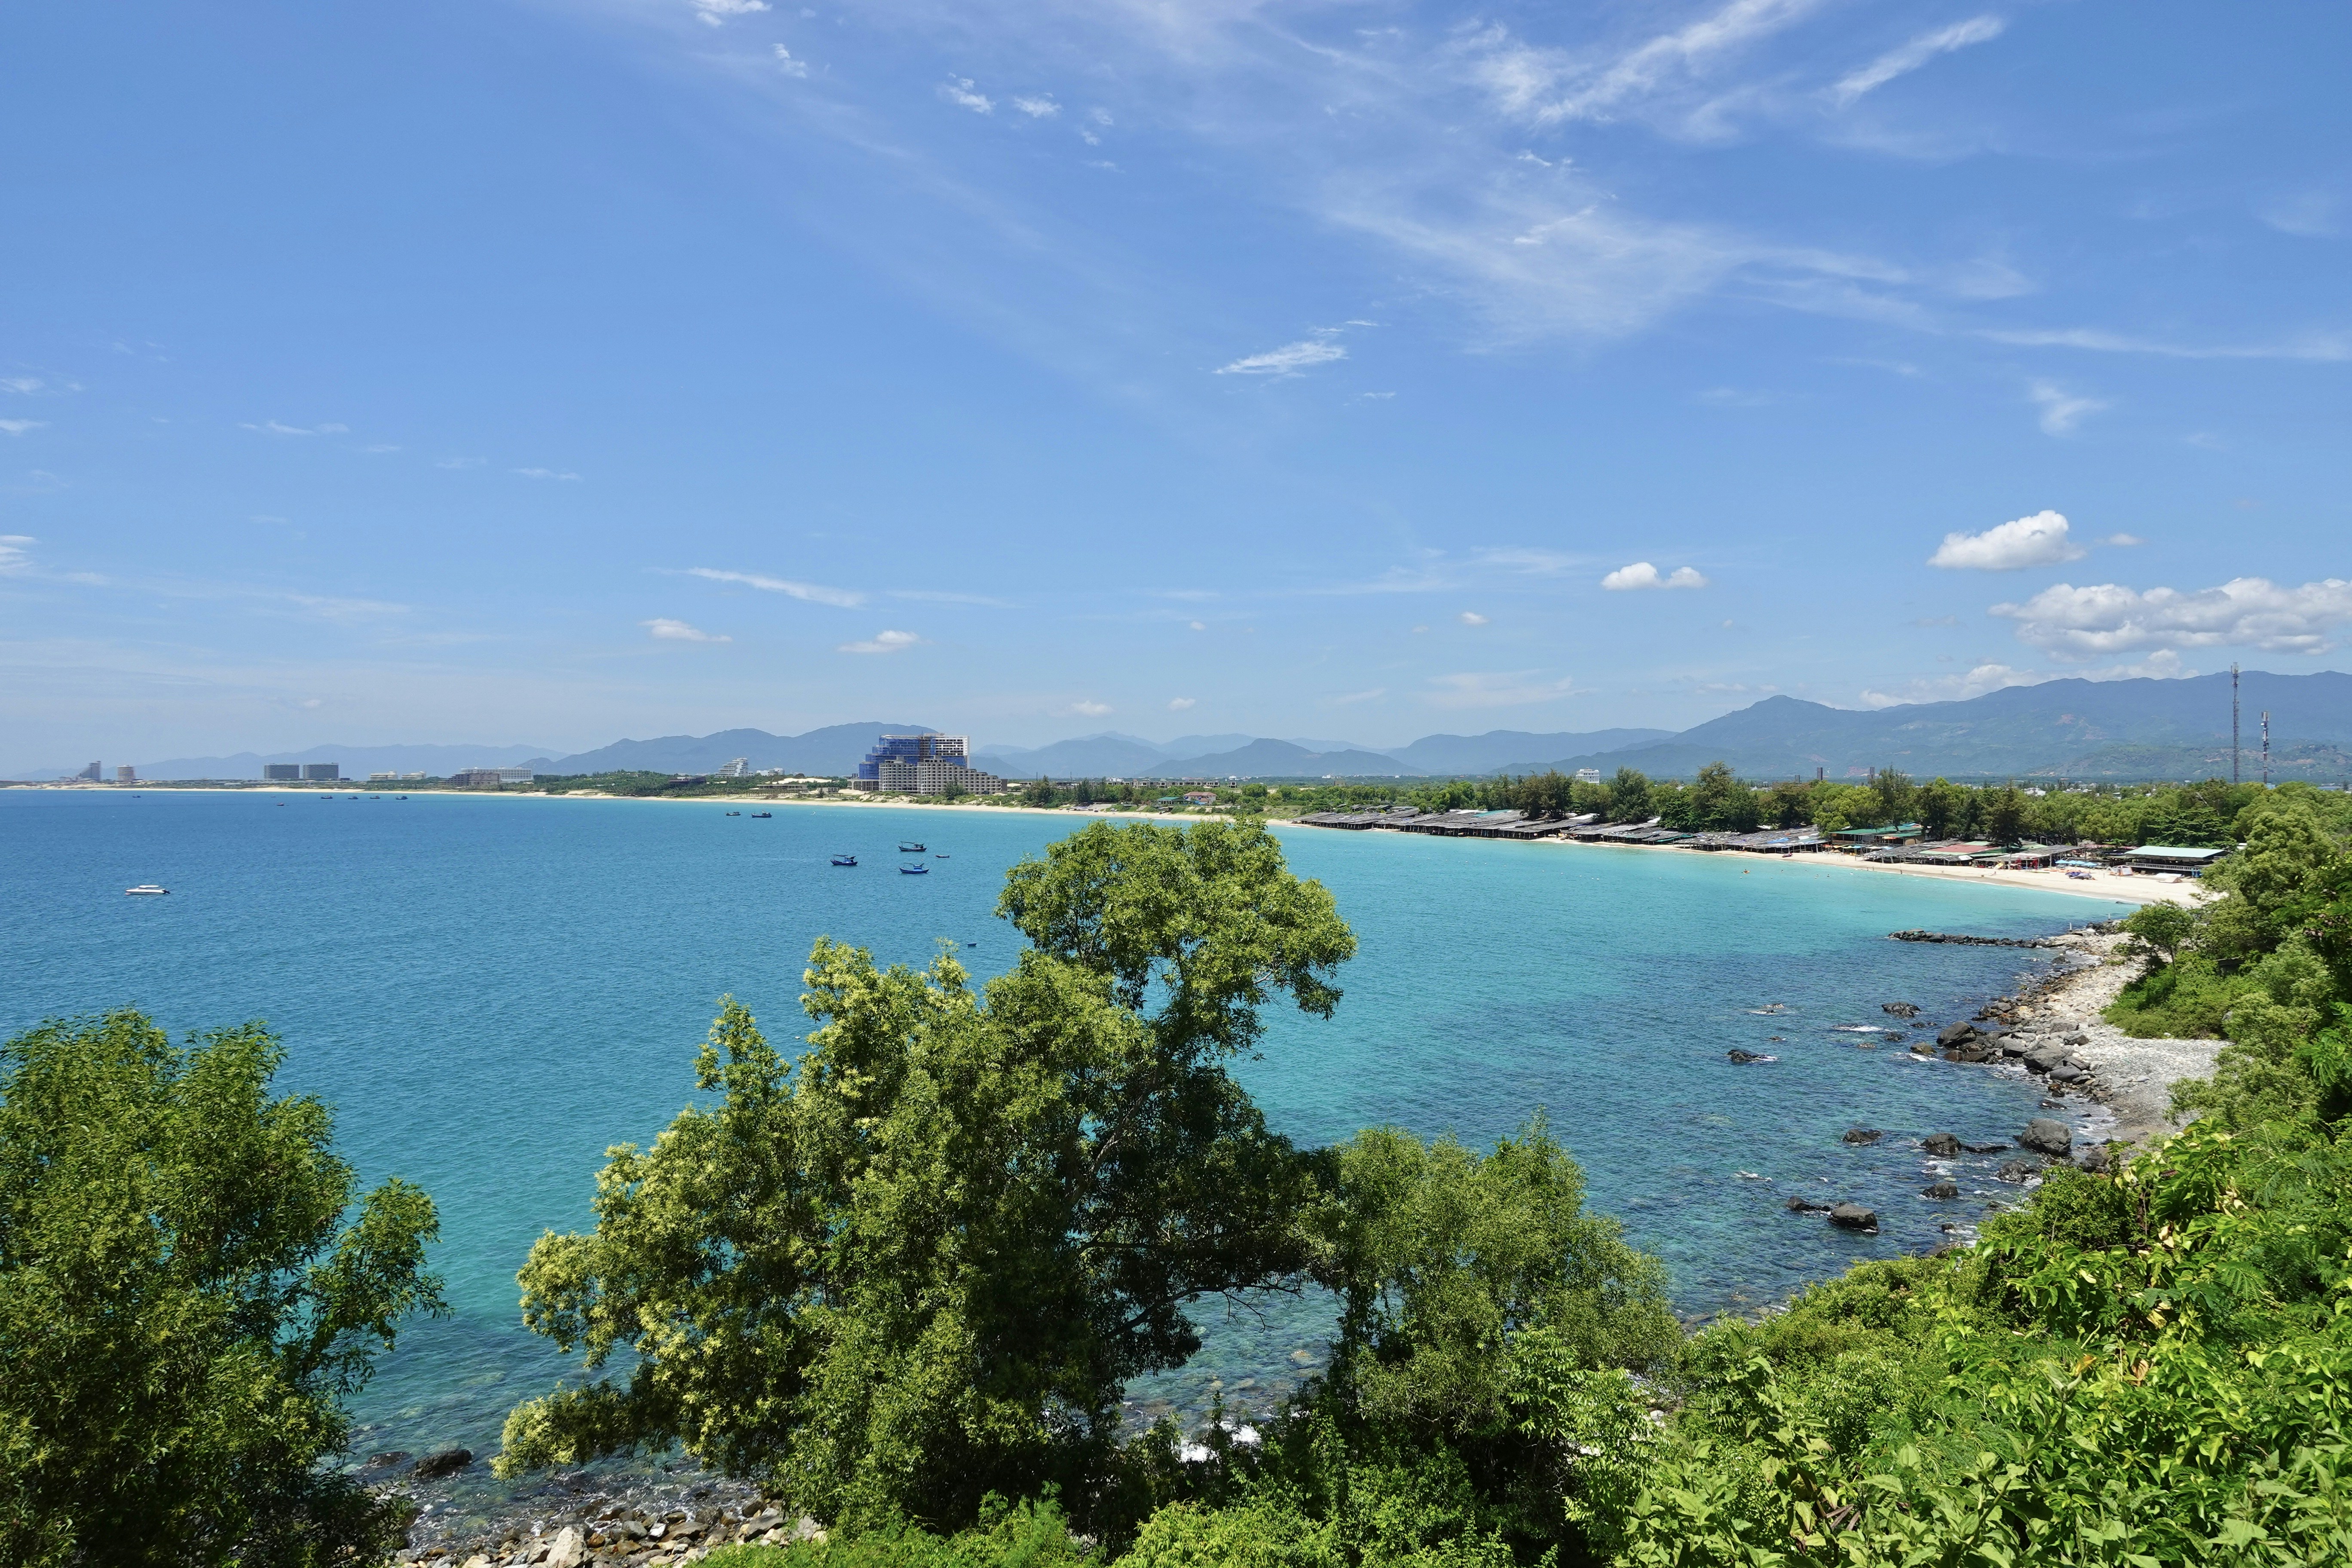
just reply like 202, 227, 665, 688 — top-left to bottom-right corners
19, 670, 2352, 783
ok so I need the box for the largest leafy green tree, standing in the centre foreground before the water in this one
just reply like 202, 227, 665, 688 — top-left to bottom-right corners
499, 823, 1355, 1523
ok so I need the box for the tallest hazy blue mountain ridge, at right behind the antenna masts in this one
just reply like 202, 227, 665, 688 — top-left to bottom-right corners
1515, 670, 2352, 781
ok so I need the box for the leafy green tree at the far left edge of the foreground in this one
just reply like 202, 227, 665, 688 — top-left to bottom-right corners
0, 1011, 442, 1568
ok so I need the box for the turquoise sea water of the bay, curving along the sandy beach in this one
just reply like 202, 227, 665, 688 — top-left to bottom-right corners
0, 790, 2119, 1485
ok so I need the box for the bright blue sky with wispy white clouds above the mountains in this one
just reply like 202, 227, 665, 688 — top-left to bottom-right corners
0, 0, 2352, 766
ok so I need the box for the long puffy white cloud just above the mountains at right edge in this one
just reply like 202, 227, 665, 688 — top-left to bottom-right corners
1992, 576, 2352, 658
